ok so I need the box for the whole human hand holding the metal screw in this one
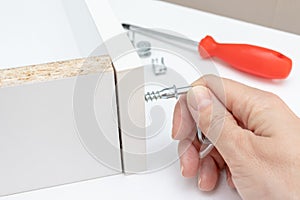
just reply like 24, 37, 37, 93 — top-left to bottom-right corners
172, 75, 300, 199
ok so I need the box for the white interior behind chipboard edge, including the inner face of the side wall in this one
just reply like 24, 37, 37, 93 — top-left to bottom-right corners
0, 0, 107, 69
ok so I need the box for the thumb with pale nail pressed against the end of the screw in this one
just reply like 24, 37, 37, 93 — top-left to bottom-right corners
187, 86, 249, 160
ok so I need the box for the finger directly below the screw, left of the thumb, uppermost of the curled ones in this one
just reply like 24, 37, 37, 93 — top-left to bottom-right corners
172, 95, 196, 140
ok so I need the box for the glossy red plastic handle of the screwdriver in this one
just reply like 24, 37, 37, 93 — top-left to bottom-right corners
198, 36, 292, 79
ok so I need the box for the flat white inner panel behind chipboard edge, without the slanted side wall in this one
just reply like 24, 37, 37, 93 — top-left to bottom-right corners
0, 0, 76, 68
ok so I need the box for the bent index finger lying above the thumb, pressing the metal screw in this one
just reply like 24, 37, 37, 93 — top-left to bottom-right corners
193, 75, 297, 136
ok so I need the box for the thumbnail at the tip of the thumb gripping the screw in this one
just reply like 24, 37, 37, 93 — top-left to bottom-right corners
187, 86, 212, 120
